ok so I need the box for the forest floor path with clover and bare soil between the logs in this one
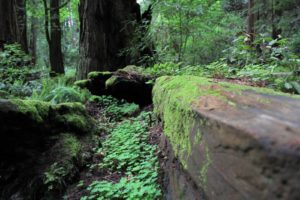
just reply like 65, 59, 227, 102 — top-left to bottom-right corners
63, 97, 163, 200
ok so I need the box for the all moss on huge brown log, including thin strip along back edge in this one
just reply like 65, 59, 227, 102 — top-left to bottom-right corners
153, 76, 298, 168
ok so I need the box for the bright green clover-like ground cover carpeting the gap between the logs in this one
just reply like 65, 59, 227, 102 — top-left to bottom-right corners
81, 113, 161, 200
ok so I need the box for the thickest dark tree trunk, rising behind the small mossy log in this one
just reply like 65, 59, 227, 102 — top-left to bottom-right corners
77, 0, 141, 79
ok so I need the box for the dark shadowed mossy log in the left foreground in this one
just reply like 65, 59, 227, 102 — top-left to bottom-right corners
0, 99, 94, 199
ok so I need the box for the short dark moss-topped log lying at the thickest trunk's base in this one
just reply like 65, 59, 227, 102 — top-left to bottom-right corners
75, 65, 155, 106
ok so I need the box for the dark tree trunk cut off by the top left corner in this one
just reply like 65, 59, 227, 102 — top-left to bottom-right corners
0, 0, 28, 52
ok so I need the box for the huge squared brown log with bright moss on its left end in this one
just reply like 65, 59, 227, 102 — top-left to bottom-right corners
153, 76, 300, 200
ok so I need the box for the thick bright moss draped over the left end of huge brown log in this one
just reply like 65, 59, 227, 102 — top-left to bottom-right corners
153, 76, 220, 168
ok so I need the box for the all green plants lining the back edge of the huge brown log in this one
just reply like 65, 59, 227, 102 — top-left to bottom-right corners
147, 35, 300, 94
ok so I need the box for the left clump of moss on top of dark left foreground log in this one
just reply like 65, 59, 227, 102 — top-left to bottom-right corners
10, 99, 50, 123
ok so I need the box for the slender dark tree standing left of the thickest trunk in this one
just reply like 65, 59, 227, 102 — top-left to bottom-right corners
43, 0, 68, 76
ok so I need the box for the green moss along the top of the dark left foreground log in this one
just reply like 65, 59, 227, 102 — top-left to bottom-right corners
8, 99, 93, 133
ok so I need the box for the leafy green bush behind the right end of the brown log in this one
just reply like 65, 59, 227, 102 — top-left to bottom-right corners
219, 35, 300, 94
